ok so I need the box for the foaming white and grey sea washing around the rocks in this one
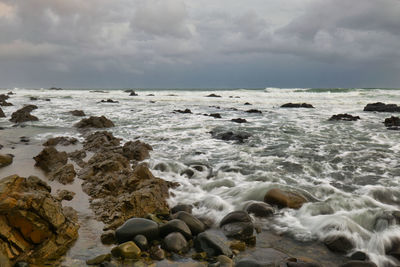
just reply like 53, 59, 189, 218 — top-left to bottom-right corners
0, 88, 400, 266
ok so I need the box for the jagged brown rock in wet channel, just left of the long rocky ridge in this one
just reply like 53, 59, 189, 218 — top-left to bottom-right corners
33, 147, 68, 172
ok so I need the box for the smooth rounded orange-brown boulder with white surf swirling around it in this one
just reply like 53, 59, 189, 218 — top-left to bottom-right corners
264, 188, 307, 209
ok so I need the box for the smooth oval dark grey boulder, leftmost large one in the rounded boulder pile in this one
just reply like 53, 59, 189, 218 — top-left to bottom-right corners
115, 218, 159, 244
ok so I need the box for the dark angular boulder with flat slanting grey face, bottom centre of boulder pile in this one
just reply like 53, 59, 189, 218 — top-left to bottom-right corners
194, 232, 232, 257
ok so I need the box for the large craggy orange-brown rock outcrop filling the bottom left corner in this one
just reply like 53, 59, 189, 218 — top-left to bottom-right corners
0, 175, 79, 266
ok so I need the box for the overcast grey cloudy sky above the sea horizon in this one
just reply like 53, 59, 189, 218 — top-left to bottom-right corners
0, 0, 400, 88
